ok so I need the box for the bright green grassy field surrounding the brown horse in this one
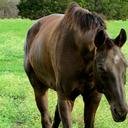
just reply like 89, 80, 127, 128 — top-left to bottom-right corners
0, 19, 128, 128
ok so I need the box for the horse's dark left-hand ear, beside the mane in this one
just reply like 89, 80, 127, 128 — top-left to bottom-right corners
95, 30, 105, 48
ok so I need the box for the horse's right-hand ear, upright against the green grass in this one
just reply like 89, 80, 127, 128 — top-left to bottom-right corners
115, 29, 127, 47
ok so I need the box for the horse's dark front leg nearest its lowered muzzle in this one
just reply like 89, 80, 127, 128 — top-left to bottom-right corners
83, 82, 102, 128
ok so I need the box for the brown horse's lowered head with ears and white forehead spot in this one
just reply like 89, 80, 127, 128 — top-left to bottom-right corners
94, 29, 128, 122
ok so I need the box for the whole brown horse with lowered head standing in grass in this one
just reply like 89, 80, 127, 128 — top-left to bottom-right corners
24, 3, 128, 128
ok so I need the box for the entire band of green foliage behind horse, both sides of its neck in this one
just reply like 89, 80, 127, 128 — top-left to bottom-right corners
17, 0, 128, 20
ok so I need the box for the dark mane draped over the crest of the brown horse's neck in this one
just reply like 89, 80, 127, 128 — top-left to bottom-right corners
62, 2, 107, 33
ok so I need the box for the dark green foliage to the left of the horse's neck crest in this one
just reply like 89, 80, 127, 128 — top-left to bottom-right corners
17, 0, 69, 19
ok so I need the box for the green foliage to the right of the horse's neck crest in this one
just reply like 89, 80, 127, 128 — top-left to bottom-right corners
85, 0, 128, 20
